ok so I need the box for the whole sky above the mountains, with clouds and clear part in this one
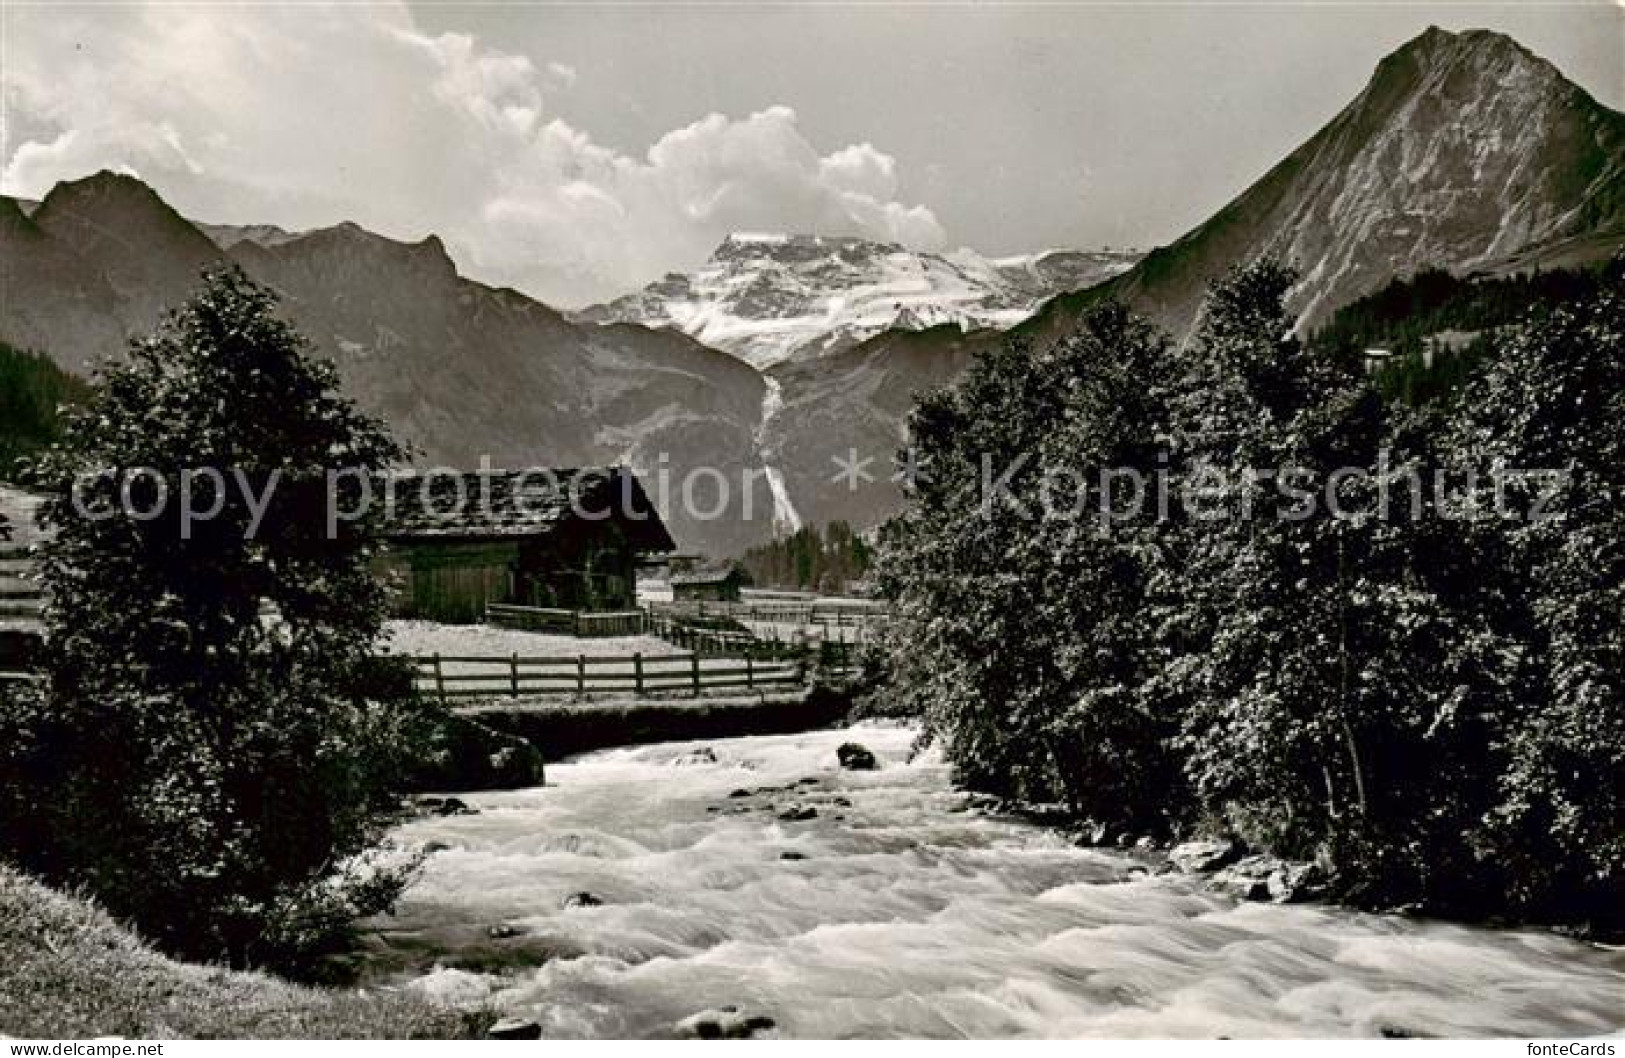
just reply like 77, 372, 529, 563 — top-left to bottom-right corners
0, 0, 1625, 307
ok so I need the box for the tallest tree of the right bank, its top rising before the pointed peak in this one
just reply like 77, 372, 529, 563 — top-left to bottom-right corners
1175, 262, 1516, 902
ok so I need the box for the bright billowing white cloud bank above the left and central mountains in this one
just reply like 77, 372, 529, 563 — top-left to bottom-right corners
0, 5, 946, 306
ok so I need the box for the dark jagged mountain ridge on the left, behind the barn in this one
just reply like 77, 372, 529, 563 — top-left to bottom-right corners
0, 172, 772, 554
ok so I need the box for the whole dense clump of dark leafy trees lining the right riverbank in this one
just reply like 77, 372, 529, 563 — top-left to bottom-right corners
878, 262, 1625, 931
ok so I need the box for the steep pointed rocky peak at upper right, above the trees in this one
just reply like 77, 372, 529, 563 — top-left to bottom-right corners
1040, 28, 1625, 342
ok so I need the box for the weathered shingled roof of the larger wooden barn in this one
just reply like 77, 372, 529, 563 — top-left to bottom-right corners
377, 466, 676, 551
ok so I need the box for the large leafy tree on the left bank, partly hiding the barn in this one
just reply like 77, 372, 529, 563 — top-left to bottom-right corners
5, 268, 429, 962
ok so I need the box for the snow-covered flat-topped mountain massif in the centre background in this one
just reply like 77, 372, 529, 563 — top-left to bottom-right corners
575, 234, 1139, 369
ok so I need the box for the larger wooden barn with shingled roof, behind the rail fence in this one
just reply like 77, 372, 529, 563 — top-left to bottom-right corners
377, 466, 676, 622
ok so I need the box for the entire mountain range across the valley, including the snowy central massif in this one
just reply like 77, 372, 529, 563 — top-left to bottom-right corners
0, 29, 1625, 554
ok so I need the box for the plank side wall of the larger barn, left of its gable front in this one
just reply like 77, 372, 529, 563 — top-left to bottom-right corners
379, 541, 520, 624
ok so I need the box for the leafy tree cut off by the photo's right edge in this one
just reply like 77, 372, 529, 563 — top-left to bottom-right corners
1451, 258, 1625, 930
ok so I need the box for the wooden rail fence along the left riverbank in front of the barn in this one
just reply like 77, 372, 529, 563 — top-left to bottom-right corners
413, 653, 808, 699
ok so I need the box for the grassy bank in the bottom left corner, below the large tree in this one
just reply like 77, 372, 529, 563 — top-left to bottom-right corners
0, 866, 483, 1038
